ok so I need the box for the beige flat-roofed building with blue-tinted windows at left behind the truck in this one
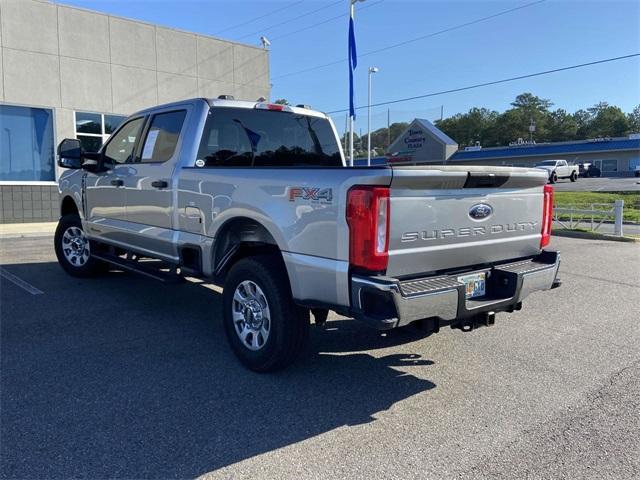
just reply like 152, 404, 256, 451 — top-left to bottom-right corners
0, 0, 270, 223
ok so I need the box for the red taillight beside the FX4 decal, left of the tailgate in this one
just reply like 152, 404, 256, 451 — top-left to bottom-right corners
347, 186, 390, 272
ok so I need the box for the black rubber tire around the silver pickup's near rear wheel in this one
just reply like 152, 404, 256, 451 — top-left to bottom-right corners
222, 255, 309, 372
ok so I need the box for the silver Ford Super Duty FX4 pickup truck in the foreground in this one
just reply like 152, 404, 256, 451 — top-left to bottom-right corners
55, 99, 559, 371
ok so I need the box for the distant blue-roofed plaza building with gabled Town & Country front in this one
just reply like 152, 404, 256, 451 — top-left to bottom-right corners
374, 119, 640, 176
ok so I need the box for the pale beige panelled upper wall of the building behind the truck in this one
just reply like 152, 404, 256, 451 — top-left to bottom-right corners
0, 0, 270, 136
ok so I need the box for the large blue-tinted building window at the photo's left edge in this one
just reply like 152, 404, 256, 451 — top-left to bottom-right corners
0, 105, 55, 181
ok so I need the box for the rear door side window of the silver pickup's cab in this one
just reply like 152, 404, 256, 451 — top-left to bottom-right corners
140, 110, 187, 163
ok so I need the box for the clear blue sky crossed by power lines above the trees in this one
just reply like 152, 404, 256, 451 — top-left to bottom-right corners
57, 0, 640, 129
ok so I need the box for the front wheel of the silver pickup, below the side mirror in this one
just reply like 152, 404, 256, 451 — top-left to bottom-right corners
53, 214, 109, 277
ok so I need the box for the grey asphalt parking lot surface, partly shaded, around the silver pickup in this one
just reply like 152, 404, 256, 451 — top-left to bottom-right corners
0, 237, 640, 479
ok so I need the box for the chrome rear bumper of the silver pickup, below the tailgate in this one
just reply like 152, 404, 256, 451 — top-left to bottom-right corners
351, 251, 560, 330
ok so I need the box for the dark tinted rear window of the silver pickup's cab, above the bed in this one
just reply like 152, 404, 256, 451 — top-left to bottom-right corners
198, 107, 342, 167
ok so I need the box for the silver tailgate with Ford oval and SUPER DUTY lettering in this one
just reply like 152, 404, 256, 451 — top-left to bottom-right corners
387, 166, 547, 277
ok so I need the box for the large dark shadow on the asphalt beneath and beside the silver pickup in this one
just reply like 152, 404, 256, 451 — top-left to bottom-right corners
0, 263, 435, 478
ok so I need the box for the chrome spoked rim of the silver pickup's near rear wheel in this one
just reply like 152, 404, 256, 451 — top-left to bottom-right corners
231, 280, 271, 351
